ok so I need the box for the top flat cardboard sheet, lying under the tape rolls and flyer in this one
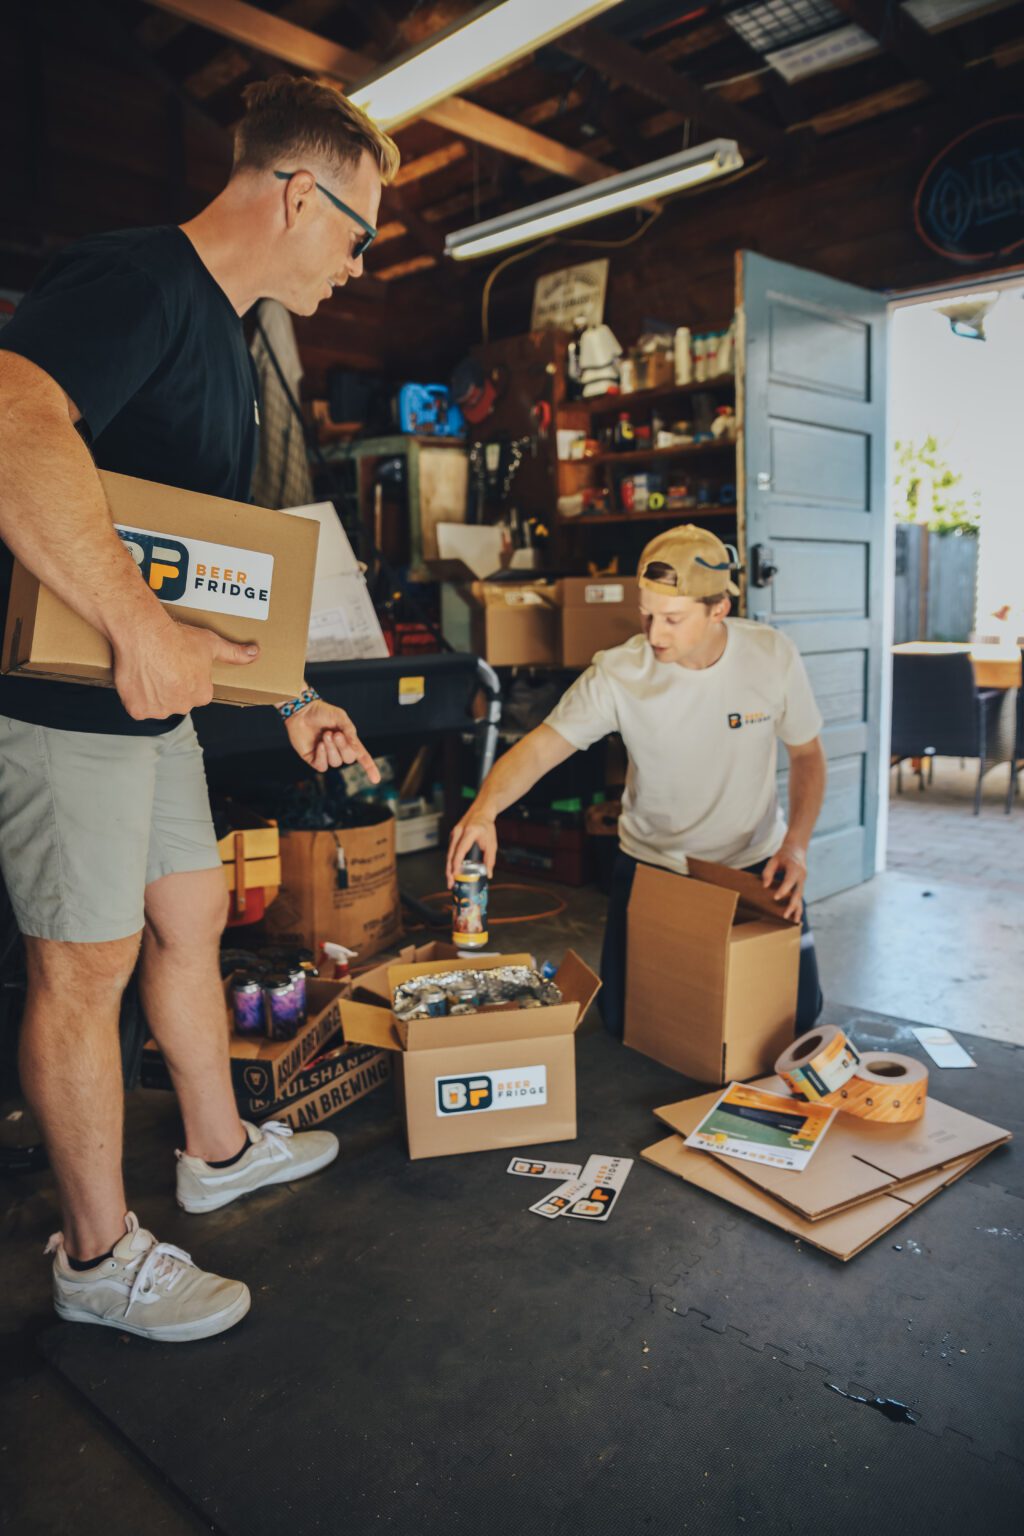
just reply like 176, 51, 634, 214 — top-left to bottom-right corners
654, 1077, 1010, 1221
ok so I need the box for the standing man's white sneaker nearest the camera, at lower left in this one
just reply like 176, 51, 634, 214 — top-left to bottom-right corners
45, 1210, 252, 1344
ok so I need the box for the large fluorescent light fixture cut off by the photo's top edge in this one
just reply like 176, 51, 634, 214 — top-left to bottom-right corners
348, 0, 619, 129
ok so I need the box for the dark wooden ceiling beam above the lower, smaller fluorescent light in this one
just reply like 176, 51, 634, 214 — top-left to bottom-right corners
557, 23, 792, 160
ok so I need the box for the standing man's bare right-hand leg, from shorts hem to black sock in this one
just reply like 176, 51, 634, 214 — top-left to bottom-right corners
140, 869, 246, 1163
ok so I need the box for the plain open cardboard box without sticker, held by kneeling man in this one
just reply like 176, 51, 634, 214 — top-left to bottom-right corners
625, 859, 800, 1083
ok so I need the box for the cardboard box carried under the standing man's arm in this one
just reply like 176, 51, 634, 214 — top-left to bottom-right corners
3, 470, 318, 703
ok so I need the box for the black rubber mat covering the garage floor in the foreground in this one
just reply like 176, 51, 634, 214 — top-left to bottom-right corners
36, 1011, 1024, 1536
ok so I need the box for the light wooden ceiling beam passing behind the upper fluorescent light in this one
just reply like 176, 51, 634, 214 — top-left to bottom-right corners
140, 0, 614, 181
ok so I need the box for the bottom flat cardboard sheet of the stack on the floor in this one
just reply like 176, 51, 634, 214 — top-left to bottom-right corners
640, 1137, 992, 1263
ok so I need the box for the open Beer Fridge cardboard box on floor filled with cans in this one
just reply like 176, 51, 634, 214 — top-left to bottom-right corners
341, 951, 600, 1158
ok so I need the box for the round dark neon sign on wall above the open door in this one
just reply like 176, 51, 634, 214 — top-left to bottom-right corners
913, 114, 1024, 263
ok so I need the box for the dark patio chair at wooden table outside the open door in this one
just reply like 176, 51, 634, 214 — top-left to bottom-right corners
890, 651, 1016, 816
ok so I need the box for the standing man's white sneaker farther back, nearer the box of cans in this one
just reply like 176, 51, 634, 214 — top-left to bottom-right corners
175, 1120, 338, 1212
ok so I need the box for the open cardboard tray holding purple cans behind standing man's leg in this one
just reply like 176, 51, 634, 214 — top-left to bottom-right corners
143, 977, 348, 1106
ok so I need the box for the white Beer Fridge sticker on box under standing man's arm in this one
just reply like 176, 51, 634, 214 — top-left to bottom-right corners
114, 522, 273, 622
